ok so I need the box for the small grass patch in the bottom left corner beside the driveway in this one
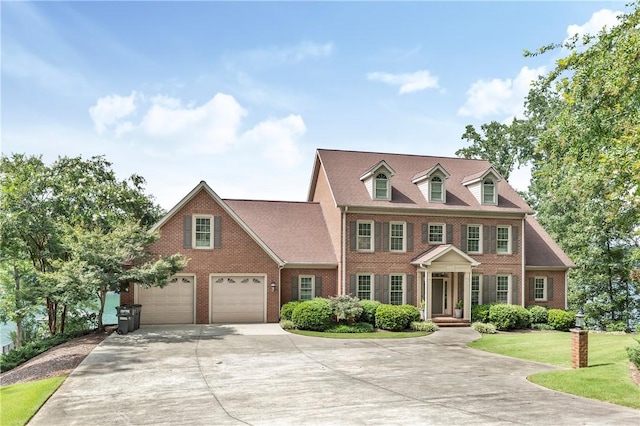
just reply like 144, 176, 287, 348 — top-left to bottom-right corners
0, 376, 67, 426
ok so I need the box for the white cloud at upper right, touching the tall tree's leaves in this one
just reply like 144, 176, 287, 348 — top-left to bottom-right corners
458, 67, 545, 119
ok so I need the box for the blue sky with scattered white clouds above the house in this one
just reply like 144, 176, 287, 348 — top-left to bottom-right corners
1, 1, 625, 209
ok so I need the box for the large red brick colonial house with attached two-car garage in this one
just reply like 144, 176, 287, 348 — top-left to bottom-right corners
121, 149, 574, 324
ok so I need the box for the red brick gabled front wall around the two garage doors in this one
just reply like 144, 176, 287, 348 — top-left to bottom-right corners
151, 189, 280, 324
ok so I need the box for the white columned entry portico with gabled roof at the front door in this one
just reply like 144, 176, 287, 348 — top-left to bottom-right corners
411, 244, 480, 320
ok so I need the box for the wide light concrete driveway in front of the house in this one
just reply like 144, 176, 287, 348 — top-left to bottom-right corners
30, 324, 640, 426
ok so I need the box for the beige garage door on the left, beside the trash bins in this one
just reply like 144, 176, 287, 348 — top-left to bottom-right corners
138, 276, 194, 325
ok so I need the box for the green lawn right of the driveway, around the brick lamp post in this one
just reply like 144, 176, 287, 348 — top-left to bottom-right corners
469, 332, 640, 409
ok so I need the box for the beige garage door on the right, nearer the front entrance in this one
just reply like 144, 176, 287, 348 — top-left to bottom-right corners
211, 276, 265, 323
